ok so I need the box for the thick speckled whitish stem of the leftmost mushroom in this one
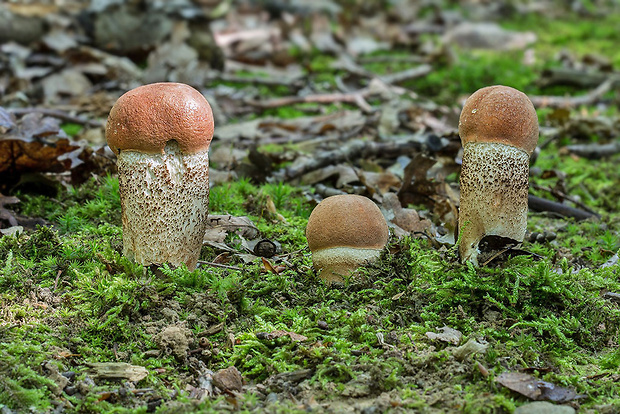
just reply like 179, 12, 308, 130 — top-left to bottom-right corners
117, 141, 209, 269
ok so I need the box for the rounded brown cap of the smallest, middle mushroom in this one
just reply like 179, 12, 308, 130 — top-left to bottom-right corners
306, 194, 389, 252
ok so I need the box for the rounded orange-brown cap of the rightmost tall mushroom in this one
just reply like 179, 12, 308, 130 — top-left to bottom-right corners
459, 85, 538, 155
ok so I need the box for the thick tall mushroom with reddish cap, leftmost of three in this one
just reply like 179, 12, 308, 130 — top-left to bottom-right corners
105, 82, 213, 270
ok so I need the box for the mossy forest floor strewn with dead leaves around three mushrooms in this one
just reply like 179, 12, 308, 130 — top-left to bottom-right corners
0, 0, 620, 414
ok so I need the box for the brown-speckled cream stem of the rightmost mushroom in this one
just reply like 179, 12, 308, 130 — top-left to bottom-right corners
459, 142, 529, 265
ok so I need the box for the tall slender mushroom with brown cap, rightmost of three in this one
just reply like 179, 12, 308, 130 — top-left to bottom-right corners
459, 85, 538, 266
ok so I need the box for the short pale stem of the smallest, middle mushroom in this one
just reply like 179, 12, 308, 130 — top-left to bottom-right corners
312, 247, 381, 283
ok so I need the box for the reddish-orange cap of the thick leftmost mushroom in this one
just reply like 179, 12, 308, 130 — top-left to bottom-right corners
105, 82, 213, 155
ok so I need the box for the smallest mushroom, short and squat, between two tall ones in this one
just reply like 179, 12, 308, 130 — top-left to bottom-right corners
306, 194, 389, 283
